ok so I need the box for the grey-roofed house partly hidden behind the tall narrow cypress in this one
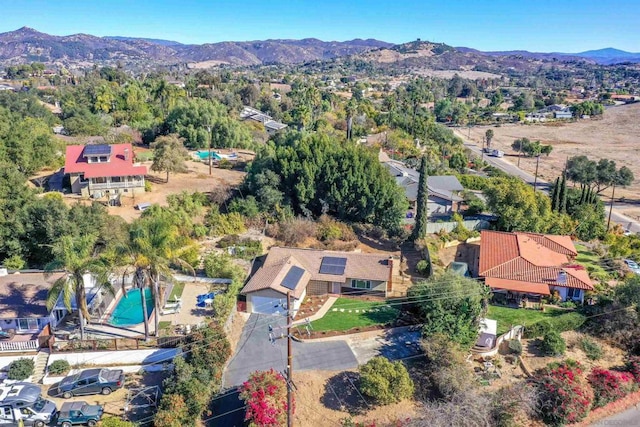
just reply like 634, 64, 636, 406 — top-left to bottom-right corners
378, 151, 464, 223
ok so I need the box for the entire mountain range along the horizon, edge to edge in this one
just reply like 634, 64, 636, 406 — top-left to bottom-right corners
0, 27, 640, 69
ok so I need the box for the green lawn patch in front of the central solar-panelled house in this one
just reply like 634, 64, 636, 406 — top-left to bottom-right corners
311, 298, 399, 331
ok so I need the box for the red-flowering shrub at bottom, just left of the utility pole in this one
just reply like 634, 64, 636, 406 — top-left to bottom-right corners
240, 369, 295, 426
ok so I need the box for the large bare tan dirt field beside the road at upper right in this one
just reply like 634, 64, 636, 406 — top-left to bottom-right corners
462, 103, 640, 200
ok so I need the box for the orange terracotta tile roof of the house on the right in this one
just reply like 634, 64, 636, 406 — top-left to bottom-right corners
478, 231, 593, 293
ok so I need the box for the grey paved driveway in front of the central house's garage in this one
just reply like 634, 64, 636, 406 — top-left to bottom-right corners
223, 313, 358, 388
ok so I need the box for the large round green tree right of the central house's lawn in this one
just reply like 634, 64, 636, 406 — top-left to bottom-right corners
408, 271, 488, 347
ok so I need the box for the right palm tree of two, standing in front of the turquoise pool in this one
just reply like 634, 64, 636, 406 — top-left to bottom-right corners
121, 215, 195, 338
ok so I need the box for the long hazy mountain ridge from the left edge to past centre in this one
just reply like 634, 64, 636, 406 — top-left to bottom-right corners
0, 27, 391, 65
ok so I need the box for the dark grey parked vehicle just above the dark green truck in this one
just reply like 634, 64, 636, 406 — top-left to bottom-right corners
58, 368, 124, 399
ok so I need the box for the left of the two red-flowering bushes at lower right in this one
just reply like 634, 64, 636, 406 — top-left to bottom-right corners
536, 363, 593, 425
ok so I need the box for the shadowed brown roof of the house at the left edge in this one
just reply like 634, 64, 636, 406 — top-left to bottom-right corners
0, 273, 61, 319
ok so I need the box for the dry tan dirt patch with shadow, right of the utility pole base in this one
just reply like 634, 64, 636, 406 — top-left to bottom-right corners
294, 371, 416, 426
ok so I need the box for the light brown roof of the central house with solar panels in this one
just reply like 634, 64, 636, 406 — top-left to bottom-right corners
242, 246, 390, 294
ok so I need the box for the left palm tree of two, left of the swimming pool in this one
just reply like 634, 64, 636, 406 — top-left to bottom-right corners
44, 235, 114, 339
